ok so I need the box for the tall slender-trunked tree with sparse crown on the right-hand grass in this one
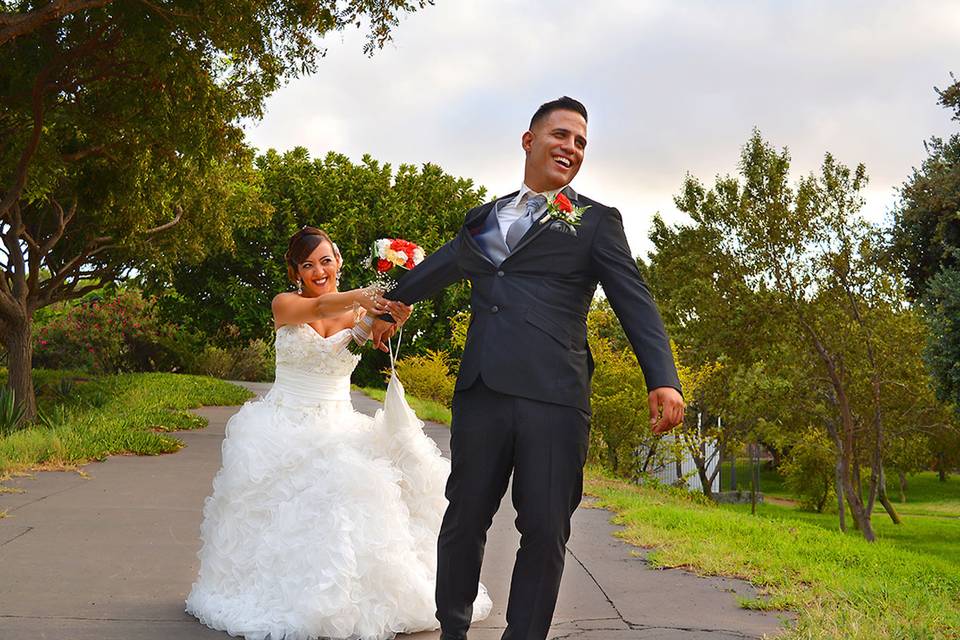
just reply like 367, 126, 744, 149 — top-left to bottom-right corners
660, 132, 936, 540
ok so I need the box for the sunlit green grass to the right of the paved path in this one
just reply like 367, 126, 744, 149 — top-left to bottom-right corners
586, 468, 960, 640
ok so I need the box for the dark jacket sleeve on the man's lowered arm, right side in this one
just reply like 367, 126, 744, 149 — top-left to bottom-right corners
591, 209, 682, 393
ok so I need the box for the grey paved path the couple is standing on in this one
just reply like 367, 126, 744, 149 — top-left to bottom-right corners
0, 385, 781, 640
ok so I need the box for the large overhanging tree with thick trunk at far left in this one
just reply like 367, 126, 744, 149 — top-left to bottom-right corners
0, 0, 424, 417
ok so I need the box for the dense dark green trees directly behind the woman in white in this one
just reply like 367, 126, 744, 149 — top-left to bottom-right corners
148, 148, 485, 385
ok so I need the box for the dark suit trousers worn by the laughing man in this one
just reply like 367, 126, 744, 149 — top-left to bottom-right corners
437, 378, 590, 640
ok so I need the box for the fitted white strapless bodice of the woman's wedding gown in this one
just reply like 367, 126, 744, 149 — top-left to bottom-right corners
273, 324, 360, 405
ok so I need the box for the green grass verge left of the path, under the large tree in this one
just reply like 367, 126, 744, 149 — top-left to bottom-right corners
0, 370, 252, 478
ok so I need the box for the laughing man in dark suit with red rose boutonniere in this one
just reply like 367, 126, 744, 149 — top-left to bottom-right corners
374, 97, 684, 640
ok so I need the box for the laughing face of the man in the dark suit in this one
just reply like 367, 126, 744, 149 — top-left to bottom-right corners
522, 109, 587, 193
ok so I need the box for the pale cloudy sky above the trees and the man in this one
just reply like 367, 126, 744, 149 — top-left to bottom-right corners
248, 0, 960, 254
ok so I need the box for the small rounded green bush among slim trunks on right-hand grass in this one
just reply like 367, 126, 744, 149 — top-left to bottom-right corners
781, 429, 837, 513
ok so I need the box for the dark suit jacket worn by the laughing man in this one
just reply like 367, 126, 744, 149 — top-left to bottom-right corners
386, 190, 680, 412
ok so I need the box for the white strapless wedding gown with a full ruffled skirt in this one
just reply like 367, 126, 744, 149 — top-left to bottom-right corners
186, 325, 492, 640
